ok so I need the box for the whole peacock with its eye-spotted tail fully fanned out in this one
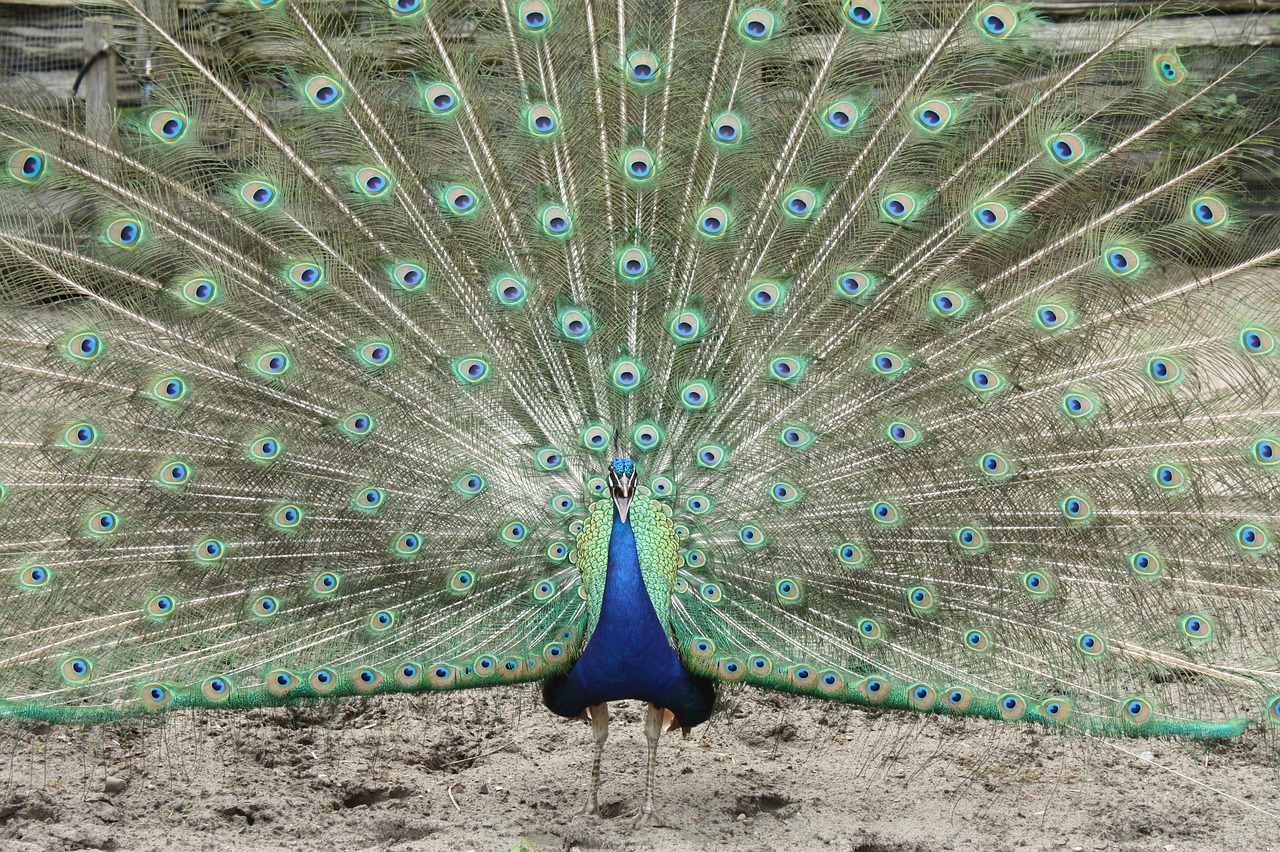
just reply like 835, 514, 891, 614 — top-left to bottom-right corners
0, 0, 1280, 824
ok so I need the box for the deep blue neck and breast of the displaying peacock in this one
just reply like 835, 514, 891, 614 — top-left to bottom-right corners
543, 510, 716, 728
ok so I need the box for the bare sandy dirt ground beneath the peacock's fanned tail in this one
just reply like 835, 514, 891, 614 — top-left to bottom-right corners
0, 687, 1280, 852
